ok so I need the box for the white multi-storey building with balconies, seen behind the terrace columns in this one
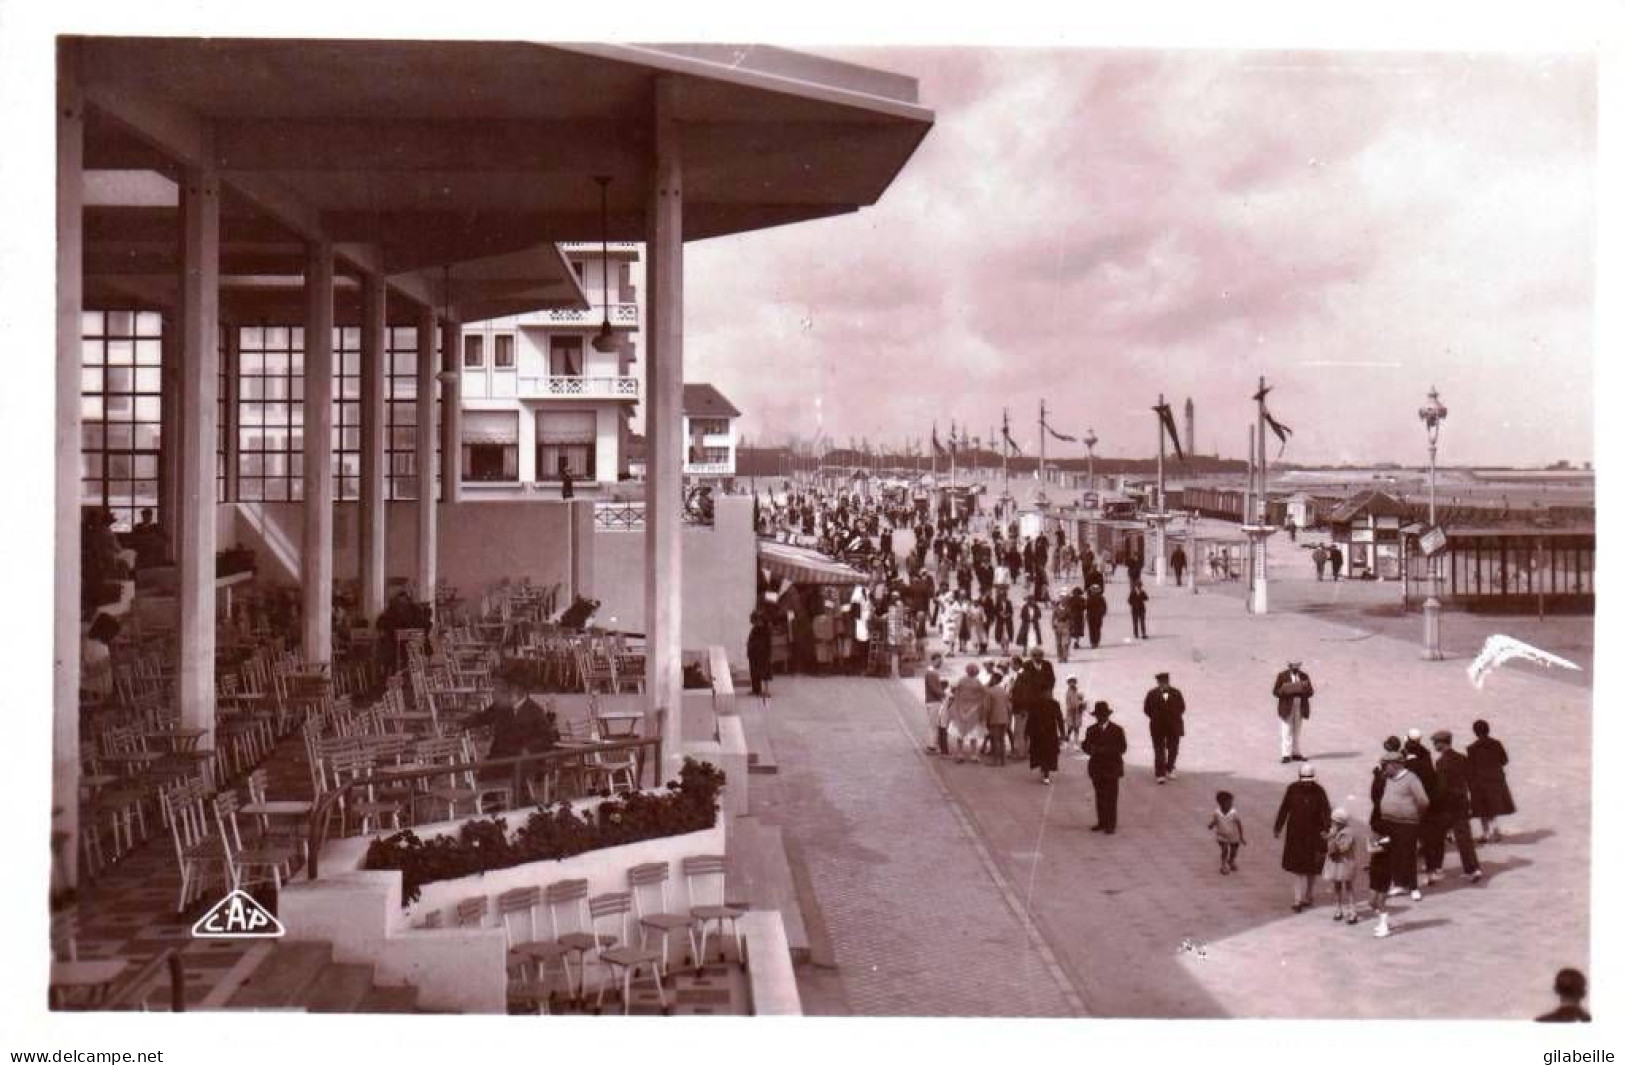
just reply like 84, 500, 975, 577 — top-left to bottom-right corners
462, 242, 640, 499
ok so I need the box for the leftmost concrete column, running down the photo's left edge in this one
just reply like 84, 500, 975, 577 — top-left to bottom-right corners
50, 54, 85, 888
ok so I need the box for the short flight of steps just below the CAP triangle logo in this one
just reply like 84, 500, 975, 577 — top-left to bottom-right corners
226, 941, 423, 1013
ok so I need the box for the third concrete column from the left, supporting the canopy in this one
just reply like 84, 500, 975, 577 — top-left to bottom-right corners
299, 242, 333, 665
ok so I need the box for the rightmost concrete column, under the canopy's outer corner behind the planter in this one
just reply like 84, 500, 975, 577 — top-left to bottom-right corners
644, 75, 683, 779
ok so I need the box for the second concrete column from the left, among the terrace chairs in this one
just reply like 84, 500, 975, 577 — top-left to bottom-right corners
177, 169, 219, 748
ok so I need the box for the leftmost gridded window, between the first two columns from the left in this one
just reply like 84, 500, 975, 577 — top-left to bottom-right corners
80, 311, 172, 528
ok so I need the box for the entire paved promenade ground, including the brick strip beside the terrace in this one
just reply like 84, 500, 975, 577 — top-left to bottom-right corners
757, 562, 1591, 1018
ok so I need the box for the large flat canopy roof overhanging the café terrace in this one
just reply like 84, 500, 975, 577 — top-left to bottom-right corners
63, 37, 933, 320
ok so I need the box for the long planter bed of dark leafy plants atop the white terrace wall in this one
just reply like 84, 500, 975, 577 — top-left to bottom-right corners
372, 758, 726, 904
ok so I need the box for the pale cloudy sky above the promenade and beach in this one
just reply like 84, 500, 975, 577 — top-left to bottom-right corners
686, 47, 1596, 463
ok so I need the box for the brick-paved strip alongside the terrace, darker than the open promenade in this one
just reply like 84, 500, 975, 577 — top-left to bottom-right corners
751, 676, 1082, 1016
